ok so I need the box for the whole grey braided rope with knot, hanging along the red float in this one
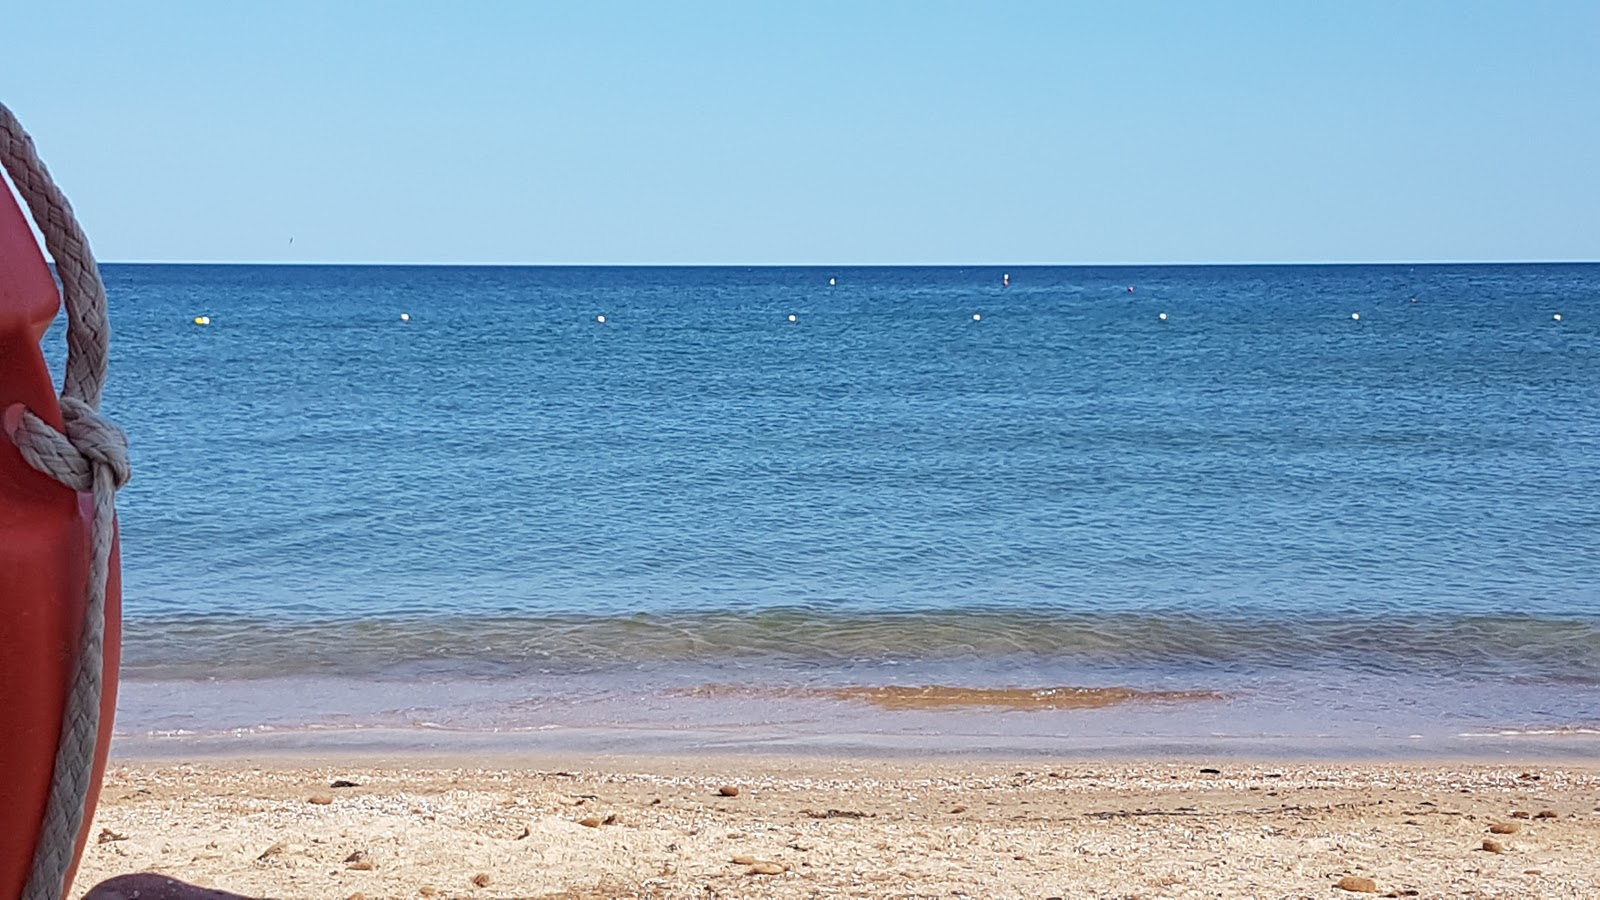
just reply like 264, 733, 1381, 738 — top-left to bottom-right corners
0, 104, 130, 900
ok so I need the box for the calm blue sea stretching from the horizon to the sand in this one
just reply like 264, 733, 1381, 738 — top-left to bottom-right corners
72, 264, 1600, 757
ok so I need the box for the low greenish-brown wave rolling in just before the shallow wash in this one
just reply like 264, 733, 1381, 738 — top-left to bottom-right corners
123, 609, 1600, 687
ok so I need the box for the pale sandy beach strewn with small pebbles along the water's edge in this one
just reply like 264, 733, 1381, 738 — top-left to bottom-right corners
77, 756, 1600, 900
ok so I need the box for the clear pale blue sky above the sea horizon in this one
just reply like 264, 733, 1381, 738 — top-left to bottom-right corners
0, 0, 1600, 266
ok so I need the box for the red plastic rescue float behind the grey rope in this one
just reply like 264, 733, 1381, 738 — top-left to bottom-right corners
0, 169, 122, 897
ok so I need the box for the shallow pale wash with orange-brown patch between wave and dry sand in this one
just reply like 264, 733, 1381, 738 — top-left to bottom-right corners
114, 669, 1600, 762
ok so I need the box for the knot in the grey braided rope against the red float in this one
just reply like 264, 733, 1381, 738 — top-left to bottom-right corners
3, 397, 133, 493
